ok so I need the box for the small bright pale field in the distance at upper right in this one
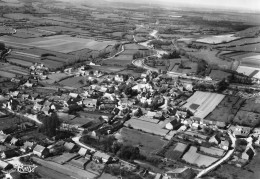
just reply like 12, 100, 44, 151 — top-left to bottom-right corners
196, 34, 240, 44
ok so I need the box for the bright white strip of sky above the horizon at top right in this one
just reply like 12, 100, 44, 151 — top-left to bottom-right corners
108, 0, 260, 12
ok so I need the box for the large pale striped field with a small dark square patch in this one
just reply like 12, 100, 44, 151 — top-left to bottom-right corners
183, 91, 225, 119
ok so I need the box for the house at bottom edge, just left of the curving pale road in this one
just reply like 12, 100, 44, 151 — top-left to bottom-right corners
166, 167, 195, 179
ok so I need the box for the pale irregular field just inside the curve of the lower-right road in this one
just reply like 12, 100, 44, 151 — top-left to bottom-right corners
182, 146, 218, 167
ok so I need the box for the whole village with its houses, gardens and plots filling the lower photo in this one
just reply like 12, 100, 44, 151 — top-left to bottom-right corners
0, 60, 260, 179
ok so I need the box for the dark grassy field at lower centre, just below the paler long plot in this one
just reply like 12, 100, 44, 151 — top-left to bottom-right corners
116, 127, 166, 155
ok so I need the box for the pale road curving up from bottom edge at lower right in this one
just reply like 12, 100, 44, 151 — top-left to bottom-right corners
196, 131, 236, 178
